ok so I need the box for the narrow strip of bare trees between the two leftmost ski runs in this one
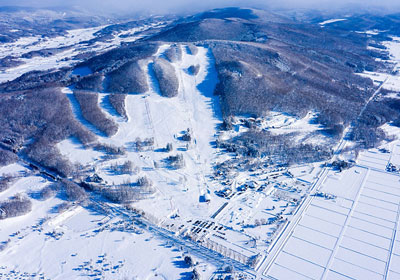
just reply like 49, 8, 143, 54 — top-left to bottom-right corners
74, 91, 118, 137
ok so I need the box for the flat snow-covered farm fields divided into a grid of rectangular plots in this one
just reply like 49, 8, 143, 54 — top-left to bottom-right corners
264, 148, 400, 279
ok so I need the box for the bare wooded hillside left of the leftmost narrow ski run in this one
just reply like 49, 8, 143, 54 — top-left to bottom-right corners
0, 88, 95, 175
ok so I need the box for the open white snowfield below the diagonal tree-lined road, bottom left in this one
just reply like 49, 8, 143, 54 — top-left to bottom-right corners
0, 202, 215, 279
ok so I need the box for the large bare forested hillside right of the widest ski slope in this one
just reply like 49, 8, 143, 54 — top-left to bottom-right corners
210, 42, 374, 131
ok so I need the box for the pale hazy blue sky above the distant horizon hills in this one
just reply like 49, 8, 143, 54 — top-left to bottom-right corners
0, 0, 400, 14
